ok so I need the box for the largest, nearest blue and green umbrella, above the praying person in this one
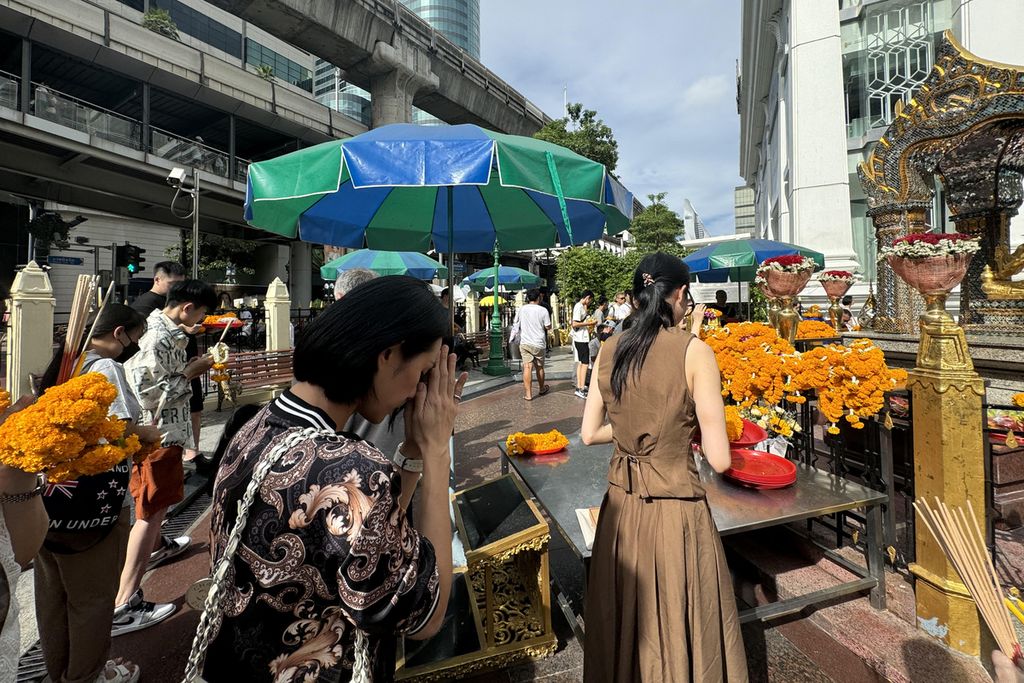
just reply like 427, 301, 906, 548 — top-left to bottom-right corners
245, 124, 633, 374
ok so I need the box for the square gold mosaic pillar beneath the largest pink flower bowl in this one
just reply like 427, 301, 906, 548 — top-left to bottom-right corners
907, 297, 992, 656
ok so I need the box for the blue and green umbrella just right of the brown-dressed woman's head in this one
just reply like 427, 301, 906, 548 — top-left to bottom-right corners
683, 240, 825, 283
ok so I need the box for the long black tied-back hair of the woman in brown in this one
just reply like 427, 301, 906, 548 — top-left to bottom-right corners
611, 252, 690, 400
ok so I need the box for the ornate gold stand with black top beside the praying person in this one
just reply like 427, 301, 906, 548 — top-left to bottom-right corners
396, 475, 557, 681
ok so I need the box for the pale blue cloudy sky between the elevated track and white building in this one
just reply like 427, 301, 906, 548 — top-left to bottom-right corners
480, 0, 742, 238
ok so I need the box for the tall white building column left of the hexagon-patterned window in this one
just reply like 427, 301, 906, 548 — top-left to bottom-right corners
785, 2, 857, 270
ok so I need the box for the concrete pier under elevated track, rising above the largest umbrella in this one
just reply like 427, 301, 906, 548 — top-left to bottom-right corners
369, 36, 438, 128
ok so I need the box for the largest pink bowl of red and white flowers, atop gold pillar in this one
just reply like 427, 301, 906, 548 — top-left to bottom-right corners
879, 232, 981, 323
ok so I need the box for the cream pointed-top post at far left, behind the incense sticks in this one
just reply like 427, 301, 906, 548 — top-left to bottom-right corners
7, 261, 56, 400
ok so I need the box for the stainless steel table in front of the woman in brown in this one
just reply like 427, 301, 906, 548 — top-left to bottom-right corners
501, 434, 889, 623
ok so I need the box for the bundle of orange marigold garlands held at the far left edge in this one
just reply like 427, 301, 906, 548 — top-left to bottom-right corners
0, 373, 141, 483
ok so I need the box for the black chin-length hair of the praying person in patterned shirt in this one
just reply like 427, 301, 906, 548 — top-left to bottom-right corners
292, 275, 452, 403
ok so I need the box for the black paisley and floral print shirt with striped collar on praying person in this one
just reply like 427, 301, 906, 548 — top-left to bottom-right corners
204, 392, 438, 683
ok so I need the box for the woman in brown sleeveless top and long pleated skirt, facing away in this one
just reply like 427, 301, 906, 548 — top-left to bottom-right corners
583, 253, 746, 683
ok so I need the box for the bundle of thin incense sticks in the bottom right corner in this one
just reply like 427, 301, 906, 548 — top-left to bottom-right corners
913, 498, 1021, 661
